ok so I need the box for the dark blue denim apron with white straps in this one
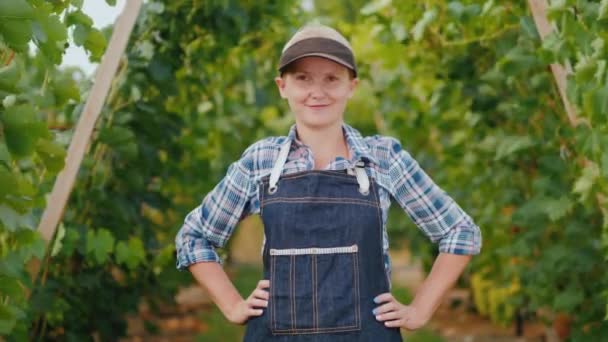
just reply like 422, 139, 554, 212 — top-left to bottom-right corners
245, 139, 402, 342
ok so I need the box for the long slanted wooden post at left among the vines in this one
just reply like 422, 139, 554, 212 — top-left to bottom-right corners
36, 0, 142, 244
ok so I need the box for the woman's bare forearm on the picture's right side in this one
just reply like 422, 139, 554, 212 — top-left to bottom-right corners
411, 253, 471, 319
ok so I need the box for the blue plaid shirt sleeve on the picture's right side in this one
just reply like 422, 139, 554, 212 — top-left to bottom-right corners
388, 138, 481, 255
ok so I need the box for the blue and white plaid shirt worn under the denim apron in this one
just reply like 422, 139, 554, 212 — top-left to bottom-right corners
175, 124, 481, 279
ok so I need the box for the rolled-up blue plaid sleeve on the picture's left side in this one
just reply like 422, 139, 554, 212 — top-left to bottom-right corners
175, 158, 255, 270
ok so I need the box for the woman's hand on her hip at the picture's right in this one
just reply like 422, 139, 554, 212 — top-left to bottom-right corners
374, 292, 430, 330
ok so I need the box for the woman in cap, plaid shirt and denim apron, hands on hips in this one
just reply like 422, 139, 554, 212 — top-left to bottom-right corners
176, 25, 481, 341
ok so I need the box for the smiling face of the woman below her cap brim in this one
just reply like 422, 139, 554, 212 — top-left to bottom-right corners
275, 56, 358, 128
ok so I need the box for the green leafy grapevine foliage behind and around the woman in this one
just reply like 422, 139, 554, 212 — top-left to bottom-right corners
0, 0, 608, 340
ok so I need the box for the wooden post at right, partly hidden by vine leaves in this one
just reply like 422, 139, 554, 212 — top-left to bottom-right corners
528, 0, 580, 127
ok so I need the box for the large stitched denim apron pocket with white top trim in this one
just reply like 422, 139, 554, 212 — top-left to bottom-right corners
269, 245, 361, 335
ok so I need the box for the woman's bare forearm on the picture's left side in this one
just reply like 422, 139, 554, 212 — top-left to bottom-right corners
188, 262, 243, 317
